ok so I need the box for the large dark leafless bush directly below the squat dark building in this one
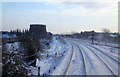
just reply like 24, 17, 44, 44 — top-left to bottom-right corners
19, 33, 42, 65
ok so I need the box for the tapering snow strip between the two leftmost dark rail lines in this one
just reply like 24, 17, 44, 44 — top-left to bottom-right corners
65, 44, 86, 75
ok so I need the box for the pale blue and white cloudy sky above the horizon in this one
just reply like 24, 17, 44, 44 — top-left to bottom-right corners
0, 0, 118, 33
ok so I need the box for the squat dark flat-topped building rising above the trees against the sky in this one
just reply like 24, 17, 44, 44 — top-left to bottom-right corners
29, 24, 47, 38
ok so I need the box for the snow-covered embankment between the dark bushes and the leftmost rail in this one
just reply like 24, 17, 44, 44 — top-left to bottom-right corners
31, 37, 72, 75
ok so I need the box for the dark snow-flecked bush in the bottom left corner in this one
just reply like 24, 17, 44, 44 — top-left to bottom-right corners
2, 53, 28, 77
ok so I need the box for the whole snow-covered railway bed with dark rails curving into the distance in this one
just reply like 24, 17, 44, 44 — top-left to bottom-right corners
44, 40, 120, 77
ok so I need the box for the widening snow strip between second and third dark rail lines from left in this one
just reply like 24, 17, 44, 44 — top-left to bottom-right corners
72, 41, 112, 75
